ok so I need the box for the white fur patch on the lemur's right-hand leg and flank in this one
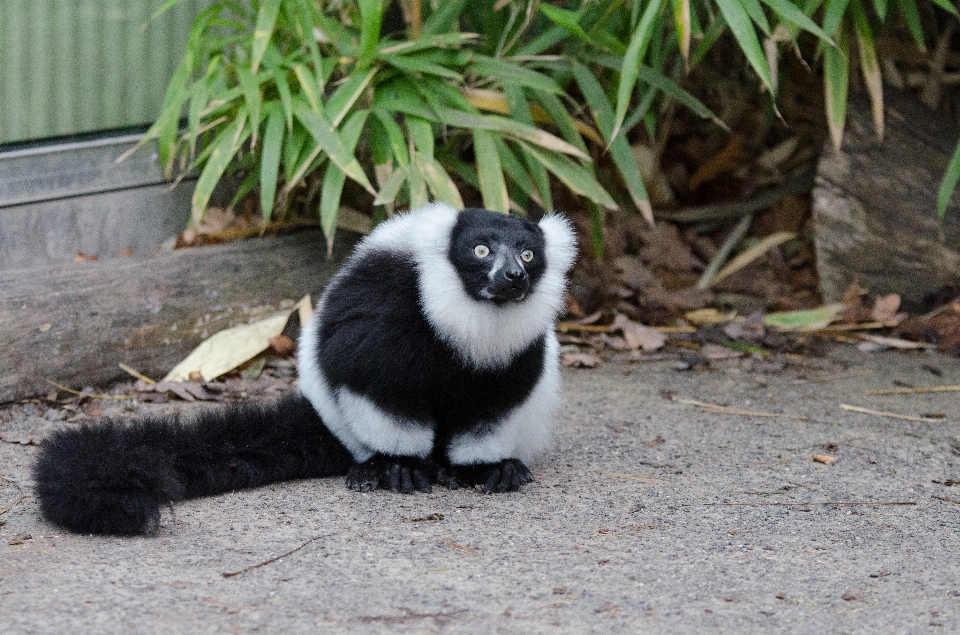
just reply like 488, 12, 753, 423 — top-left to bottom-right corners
447, 331, 560, 465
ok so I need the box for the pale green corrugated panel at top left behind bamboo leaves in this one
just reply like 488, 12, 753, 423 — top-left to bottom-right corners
0, 0, 211, 143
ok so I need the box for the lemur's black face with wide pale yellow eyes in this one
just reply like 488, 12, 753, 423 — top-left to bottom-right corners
450, 209, 547, 305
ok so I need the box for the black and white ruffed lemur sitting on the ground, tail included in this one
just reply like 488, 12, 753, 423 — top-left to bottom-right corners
34, 203, 576, 535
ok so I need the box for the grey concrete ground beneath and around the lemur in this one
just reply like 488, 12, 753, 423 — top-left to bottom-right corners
0, 346, 960, 634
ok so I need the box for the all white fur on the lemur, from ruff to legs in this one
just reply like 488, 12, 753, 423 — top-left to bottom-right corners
297, 203, 576, 464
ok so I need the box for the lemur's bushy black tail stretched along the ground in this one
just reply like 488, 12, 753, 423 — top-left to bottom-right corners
34, 393, 353, 535
